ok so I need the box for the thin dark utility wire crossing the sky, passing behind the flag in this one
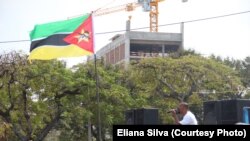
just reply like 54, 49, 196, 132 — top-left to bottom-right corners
0, 10, 250, 44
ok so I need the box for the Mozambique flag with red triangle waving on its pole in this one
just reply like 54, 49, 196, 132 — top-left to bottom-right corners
28, 14, 94, 60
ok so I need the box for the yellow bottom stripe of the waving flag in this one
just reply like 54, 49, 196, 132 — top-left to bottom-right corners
28, 44, 92, 60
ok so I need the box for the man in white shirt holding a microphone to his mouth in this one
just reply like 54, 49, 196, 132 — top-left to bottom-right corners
171, 102, 198, 125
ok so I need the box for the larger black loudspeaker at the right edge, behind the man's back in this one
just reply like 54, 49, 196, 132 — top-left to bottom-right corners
203, 99, 250, 124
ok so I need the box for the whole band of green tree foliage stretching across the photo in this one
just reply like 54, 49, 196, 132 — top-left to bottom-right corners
0, 51, 245, 141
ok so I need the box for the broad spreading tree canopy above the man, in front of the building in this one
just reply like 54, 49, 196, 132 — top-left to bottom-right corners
131, 55, 241, 121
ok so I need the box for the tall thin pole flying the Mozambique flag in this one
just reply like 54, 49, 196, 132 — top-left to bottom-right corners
91, 12, 102, 141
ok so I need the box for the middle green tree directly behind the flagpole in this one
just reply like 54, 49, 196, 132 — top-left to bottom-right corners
58, 61, 134, 141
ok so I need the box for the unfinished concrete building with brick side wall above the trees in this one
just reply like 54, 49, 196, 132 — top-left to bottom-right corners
88, 31, 182, 64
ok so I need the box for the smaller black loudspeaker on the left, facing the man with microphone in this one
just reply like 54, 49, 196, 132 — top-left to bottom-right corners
125, 108, 159, 125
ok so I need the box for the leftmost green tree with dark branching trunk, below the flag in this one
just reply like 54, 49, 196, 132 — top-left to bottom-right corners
0, 52, 83, 141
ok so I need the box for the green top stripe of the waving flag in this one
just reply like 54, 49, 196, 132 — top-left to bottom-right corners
30, 14, 89, 40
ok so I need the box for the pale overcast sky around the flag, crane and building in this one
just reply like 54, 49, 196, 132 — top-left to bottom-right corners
0, 0, 250, 66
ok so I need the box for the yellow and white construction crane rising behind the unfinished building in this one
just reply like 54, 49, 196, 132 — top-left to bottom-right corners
93, 0, 164, 32
